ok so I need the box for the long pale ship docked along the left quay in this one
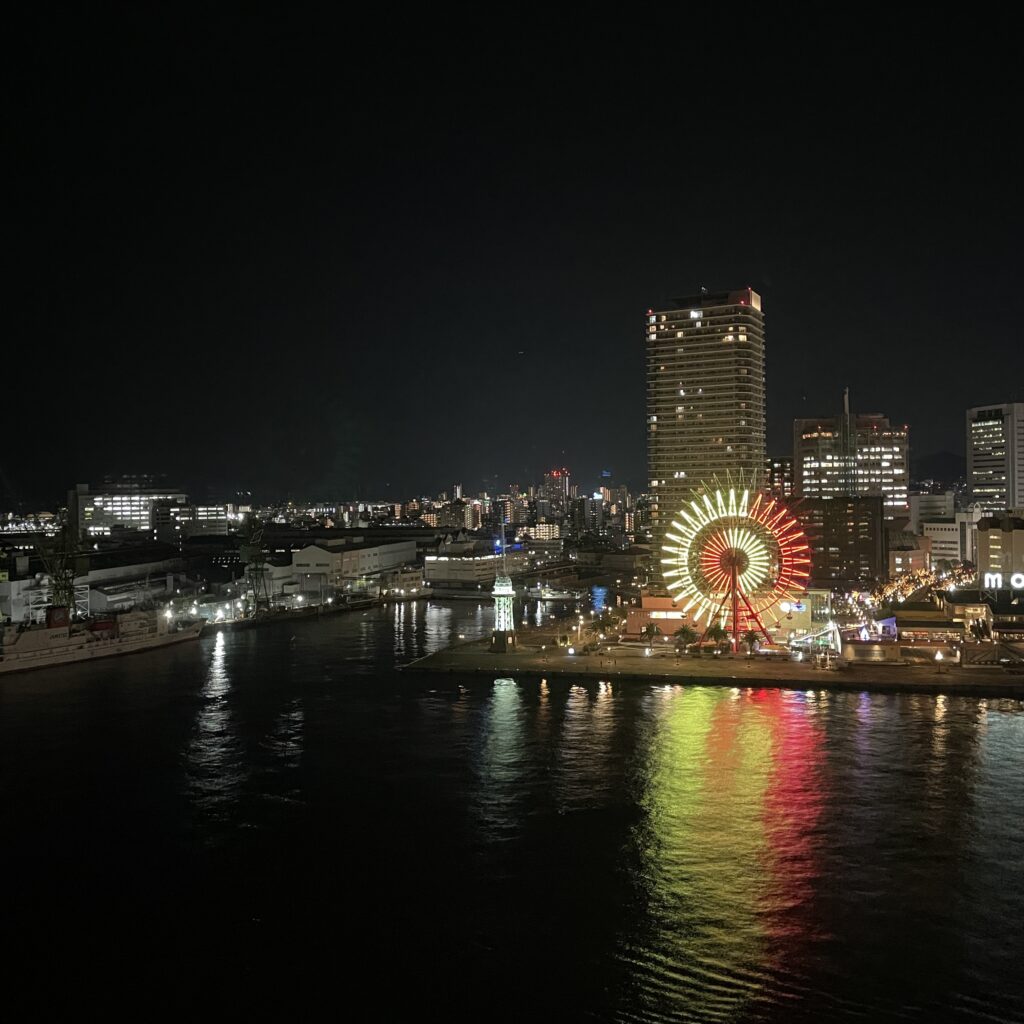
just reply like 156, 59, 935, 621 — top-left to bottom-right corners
0, 607, 203, 676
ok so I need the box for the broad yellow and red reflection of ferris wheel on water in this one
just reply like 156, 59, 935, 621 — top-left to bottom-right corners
628, 688, 821, 1020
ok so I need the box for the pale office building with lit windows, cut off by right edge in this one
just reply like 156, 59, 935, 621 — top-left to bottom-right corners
967, 401, 1024, 512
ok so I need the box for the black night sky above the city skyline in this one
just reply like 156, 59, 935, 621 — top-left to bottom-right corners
6, 12, 1024, 508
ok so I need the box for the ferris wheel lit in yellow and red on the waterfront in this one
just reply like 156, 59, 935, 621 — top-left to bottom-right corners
662, 484, 811, 650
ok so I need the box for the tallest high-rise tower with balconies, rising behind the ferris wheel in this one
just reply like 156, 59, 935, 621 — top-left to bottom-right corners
645, 288, 765, 549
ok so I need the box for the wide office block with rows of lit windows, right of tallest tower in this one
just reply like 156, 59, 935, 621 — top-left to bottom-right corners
793, 412, 910, 519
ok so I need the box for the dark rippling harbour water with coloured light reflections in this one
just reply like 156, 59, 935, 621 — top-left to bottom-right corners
0, 602, 1024, 1021
